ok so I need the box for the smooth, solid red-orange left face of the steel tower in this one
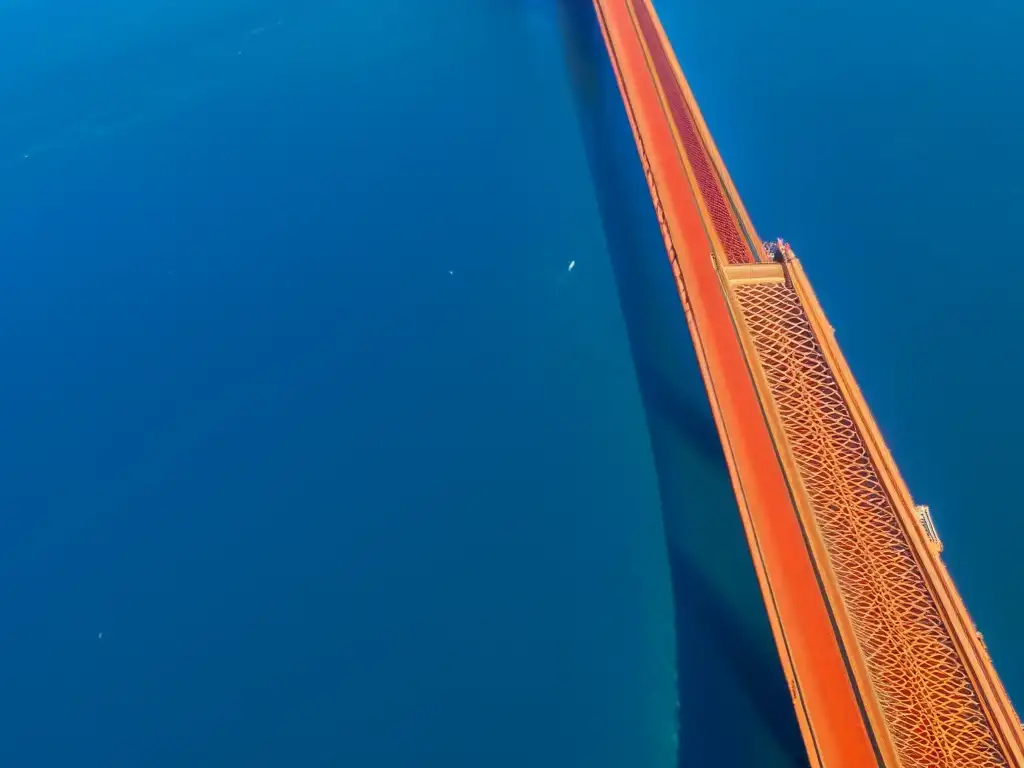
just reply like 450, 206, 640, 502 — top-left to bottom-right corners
594, 0, 884, 768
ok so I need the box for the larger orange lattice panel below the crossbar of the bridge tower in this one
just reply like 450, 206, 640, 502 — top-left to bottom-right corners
733, 282, 1008, 768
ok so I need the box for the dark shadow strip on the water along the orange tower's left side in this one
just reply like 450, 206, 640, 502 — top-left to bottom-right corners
558, 0, 808, 768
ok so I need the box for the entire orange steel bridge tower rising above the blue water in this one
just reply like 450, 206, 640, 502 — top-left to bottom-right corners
593, 0, 1024, 768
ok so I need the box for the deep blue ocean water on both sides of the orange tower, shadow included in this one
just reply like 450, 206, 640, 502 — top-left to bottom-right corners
0, 0, 1024, 768
